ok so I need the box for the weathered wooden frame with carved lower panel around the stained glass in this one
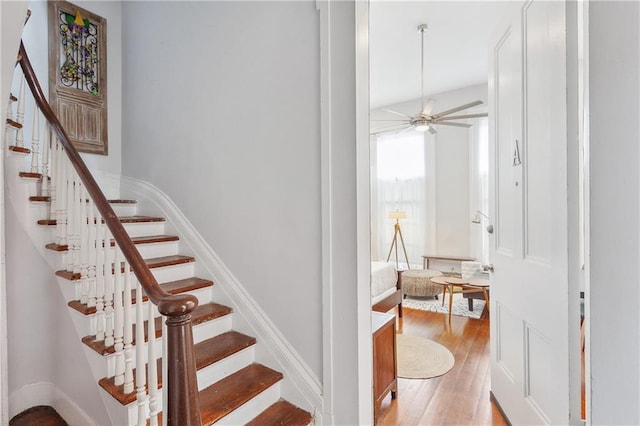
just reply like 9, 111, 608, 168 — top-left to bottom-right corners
49, 1, 109, 155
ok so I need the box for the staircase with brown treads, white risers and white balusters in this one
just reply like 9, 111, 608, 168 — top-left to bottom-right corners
5, 36, 313, 425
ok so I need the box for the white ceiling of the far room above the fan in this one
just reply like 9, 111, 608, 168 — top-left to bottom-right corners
369, 0, 508, 109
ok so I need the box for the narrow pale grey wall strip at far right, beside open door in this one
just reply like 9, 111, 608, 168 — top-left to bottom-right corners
588, 1, 640, 424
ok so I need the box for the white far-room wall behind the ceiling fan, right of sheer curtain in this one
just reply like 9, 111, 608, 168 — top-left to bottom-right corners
371, 84, 487, 266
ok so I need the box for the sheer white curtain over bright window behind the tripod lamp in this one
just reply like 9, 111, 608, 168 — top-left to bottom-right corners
371, 130, 428, 268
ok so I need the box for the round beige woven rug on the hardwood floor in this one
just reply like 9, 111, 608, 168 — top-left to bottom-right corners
396, 334, 455, 379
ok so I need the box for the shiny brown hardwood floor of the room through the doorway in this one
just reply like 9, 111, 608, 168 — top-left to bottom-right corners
378, 308, 509, 426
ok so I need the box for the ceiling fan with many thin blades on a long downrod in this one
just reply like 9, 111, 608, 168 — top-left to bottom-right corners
373, 24, 487, 134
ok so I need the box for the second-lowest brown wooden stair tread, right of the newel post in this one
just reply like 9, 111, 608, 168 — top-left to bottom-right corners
200, 364, 283, 425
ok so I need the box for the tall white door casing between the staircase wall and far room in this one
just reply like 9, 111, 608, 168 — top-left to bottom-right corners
316, 0, 364, 424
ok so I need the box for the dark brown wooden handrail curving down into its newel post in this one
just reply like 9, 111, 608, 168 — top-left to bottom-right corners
18, 42, 201, 425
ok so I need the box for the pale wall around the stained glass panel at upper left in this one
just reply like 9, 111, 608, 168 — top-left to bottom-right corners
20, 1, 122, 175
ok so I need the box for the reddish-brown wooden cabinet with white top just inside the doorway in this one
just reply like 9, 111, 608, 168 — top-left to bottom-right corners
371, 312, 398, 422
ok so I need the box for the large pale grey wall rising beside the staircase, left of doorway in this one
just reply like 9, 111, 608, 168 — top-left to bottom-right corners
123, 1, 322, 377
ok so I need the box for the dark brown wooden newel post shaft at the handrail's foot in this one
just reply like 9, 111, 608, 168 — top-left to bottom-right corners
166, 314, 202, 426
